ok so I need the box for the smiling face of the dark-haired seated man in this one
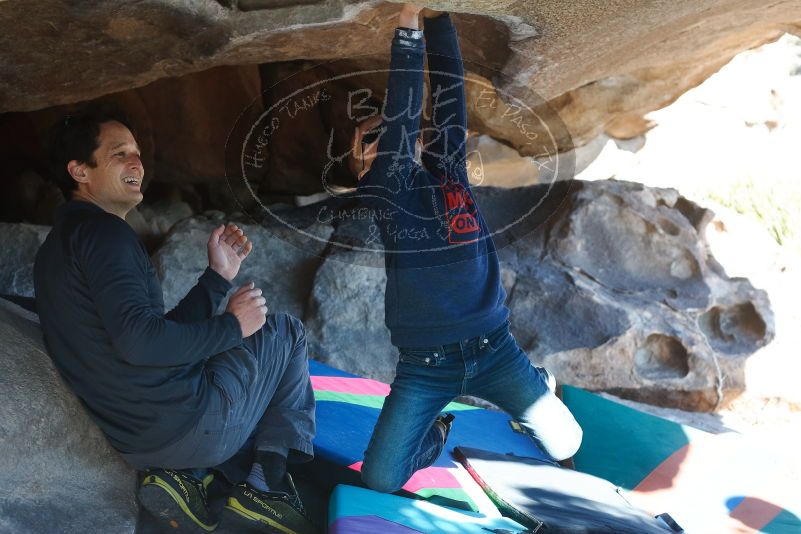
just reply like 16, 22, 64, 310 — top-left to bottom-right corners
68, 121, 145, 218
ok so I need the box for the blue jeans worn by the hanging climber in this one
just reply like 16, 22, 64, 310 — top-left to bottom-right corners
362, 322, 582, 492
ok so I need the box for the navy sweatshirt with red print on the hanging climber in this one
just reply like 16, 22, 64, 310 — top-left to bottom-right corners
357, 14, 509, 347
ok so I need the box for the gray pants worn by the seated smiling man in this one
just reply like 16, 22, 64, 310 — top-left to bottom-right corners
123, 314, 314, 483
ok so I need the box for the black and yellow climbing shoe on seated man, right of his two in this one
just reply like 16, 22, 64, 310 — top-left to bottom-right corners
220, 473, 318, 534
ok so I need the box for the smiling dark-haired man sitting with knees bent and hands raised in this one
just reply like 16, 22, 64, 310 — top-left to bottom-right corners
34, 106, 315, 533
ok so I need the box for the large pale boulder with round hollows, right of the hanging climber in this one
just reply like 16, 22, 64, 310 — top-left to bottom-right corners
502, 181, 774, 410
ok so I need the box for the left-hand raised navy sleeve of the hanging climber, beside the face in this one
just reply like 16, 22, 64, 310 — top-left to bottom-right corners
359, 28, 425, 204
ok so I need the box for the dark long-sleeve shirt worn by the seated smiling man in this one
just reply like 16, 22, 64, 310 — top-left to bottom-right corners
34, 200, 242, 452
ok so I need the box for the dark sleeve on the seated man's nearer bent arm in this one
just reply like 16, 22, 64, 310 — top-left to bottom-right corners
73, 215, 242, 367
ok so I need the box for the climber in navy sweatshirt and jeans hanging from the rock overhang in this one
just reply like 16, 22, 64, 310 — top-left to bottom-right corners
349, 4, 582, 498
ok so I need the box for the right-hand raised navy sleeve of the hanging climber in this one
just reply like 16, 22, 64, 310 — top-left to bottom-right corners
423, 13, 469, 186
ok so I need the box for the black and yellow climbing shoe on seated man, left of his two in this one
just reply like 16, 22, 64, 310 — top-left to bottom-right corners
139, 469, 217, 533
